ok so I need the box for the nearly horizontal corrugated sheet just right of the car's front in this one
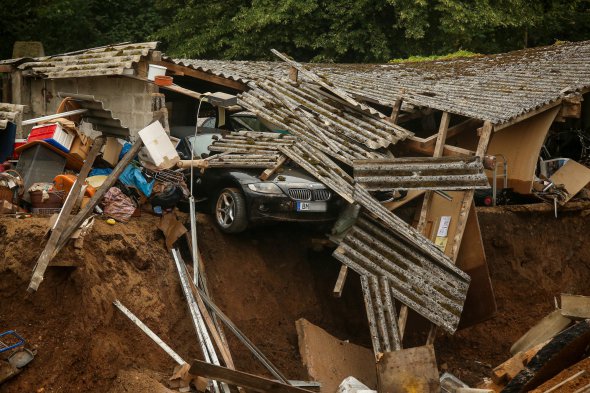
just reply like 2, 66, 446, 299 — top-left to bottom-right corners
354, 156, 490, 191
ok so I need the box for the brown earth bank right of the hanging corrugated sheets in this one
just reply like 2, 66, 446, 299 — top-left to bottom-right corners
436, 208, 590, 384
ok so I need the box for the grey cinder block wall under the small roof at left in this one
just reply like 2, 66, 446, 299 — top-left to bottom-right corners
23, 76, 158, 140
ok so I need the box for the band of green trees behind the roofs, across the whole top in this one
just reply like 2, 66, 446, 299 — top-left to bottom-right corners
0, 0, 590, 62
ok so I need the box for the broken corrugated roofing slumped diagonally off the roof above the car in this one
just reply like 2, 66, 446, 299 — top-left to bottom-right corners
238, 78, 411, 165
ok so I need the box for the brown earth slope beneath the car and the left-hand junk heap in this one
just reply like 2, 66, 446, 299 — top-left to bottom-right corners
0, 215, 369, 392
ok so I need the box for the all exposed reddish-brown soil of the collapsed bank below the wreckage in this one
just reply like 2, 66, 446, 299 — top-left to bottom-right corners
0, 204, 590, 393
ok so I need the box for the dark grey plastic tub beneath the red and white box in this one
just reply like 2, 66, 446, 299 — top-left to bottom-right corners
16, 144, 66, 202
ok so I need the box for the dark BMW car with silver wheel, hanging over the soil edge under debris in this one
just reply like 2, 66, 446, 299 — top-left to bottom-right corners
177, 129, 342, 233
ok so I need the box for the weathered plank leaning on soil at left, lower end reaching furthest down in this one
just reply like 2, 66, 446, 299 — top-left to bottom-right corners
28, 137, 106, 292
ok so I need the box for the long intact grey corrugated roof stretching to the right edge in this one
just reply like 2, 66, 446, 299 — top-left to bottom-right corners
174, 41, 590, 124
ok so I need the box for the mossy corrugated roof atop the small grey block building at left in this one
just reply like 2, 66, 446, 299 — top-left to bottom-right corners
18, 42, 158, 79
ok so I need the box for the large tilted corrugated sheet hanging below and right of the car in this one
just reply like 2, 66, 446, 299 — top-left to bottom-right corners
333, 214, 470, 333
